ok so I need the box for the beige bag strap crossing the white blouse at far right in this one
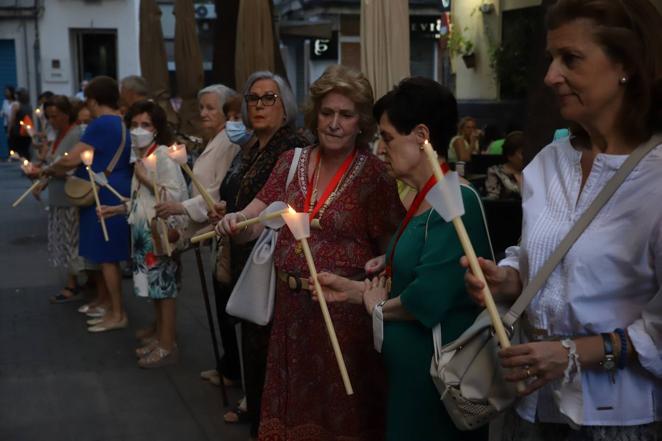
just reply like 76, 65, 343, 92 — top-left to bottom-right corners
503, 134, 662, 326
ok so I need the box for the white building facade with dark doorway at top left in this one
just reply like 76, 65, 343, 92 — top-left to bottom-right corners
0, 0, 140, 99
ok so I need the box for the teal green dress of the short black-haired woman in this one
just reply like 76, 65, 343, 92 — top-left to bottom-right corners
382, 186, 492, 441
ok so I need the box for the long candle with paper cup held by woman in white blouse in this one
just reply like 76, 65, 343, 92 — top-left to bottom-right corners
423, 139, 525, 391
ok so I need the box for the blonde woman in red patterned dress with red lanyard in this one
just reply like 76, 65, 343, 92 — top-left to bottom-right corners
218, 66, 404, 441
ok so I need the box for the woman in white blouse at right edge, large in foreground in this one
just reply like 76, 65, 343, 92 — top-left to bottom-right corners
462, 0, 662, 441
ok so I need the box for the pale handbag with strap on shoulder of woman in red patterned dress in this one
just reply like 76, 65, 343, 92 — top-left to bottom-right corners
225, 148, 303, 326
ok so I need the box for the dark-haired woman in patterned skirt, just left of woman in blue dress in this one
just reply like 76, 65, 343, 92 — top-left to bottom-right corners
35, 96, 98, 303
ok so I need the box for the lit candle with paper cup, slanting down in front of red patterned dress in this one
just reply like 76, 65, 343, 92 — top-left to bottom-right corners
283, 207, 354, 395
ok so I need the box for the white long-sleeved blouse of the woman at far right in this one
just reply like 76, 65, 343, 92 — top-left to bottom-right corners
499, 138, 662, 426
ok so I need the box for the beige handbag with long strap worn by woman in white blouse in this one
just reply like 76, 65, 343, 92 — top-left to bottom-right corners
430, 135, 662, 430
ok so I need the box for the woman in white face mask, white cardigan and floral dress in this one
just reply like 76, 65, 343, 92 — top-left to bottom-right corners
99, 101, 188, 368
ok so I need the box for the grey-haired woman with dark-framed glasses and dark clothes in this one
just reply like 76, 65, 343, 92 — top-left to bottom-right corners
206, 71, 308, 437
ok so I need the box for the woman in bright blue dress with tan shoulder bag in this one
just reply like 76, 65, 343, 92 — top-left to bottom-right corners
47, 76, 132, 332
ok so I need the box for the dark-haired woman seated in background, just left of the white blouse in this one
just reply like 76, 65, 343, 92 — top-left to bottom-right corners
485, 131, 525, 199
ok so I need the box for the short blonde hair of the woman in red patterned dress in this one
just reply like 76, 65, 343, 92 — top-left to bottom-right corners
303, 64, 377, 147
